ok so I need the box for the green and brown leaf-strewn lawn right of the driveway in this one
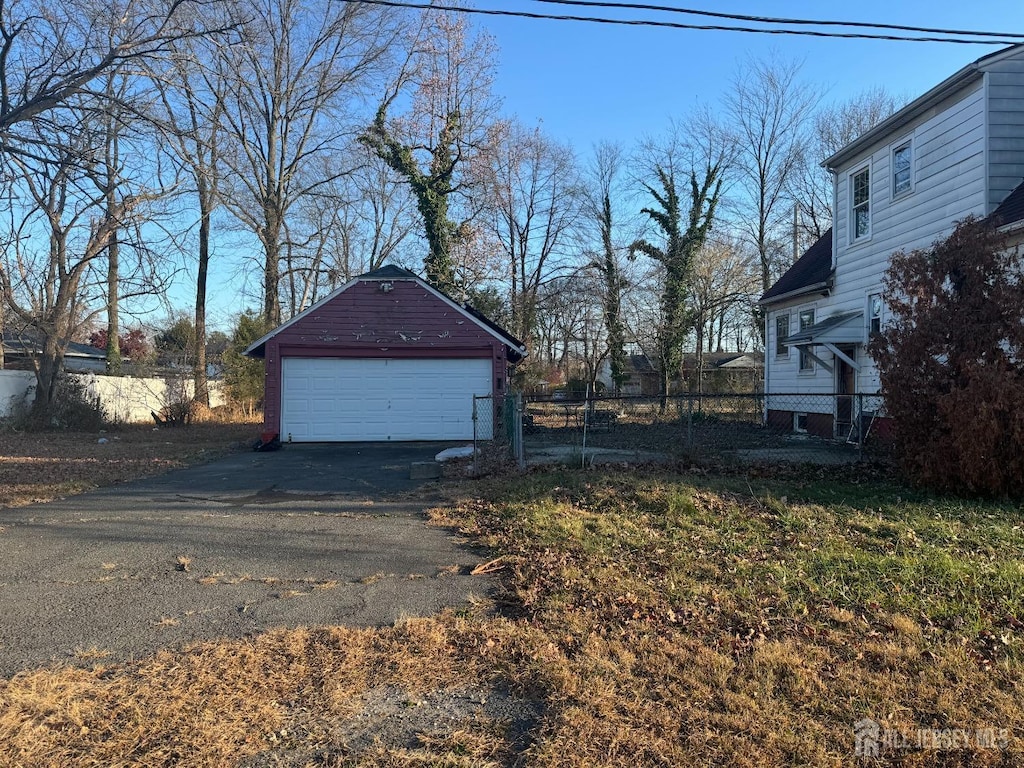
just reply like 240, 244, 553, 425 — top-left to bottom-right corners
440, 470, 1024, 765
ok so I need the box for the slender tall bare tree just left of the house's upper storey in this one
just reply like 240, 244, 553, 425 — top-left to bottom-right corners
725, 58, 818, 291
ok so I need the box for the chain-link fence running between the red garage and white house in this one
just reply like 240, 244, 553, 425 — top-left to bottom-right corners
512, 393, 888, 464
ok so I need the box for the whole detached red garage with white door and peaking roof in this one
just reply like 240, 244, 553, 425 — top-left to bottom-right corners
246, 266, 525, 442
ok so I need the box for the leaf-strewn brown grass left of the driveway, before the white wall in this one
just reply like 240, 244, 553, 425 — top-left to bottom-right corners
0, 423, 259, 509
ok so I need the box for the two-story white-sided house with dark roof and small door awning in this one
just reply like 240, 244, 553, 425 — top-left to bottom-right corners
760, 45, 1024, 437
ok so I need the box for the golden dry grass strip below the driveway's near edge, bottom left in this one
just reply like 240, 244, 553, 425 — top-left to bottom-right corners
0, 615, 543, 768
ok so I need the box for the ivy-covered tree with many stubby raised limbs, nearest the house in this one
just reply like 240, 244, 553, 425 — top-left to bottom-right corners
630, 164, 722, 410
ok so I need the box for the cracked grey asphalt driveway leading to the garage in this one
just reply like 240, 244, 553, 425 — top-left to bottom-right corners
0, 443, 492, 676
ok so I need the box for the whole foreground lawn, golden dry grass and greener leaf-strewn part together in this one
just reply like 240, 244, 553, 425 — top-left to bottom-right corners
0, 473, 1024, 768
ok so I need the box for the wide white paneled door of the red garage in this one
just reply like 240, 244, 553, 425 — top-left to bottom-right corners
281, 357, 493, 442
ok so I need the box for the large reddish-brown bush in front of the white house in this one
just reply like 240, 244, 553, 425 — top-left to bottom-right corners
869, 219, 1024, 496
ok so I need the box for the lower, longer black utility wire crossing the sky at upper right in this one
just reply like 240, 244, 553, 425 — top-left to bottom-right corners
343, 0, 1021, 45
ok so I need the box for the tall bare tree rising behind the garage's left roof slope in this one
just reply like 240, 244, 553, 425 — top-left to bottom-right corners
211, 0, 395, 325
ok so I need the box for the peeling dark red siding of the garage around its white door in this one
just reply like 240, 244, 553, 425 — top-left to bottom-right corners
248, 273, 520, 442
